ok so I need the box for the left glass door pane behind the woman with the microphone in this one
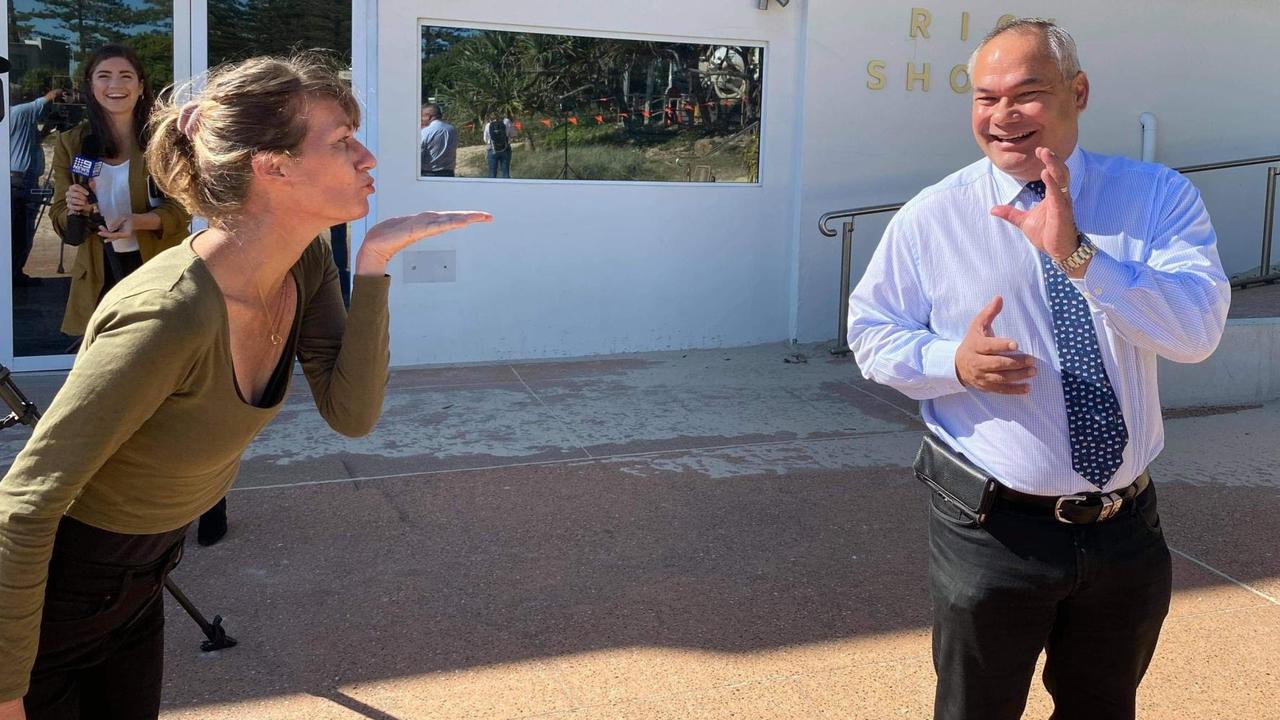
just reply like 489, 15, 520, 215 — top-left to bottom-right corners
0, 0, 191, 370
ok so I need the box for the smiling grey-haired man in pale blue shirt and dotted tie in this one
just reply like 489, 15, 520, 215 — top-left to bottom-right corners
849, 19, 1229, 720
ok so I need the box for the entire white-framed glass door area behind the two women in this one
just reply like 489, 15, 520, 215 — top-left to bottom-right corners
0, 0, 364, 370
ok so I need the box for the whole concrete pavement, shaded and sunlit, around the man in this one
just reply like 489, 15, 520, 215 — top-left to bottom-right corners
0, 345, 1280, 720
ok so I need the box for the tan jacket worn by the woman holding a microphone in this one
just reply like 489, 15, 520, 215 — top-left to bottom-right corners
50, 122, 191, 336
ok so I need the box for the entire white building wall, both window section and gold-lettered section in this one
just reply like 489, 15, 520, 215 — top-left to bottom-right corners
370, 0, 1280, 365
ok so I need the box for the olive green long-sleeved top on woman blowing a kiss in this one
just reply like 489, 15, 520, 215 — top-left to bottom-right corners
0, 238, 390, 701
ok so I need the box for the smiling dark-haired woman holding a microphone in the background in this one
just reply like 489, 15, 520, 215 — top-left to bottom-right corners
50, 45, 191, 336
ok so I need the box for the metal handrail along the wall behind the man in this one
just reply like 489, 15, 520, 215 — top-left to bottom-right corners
818, 155, 1280, 355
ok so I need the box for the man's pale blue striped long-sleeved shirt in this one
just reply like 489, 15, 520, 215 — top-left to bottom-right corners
849, 149, 1230, 496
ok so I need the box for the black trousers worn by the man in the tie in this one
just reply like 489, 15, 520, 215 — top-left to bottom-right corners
929, 476, 1172, 720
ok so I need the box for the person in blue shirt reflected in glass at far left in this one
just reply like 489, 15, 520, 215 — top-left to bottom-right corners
9, 79, 63, 287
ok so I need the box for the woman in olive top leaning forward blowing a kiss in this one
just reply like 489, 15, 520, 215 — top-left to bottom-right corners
0, 55, 492, 720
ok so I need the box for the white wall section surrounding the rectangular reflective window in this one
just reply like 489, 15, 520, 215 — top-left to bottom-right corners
375, 0, 803, 364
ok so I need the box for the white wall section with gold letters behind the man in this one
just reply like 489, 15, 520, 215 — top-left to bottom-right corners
795, 0, 1280, 341
